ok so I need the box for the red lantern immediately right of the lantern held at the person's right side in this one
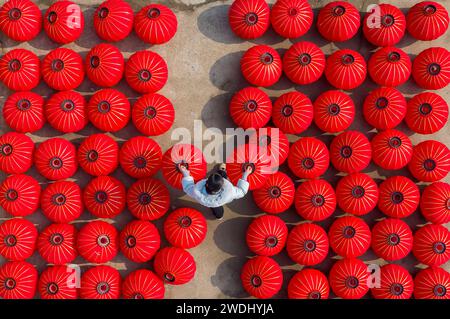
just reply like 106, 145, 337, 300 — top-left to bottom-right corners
288, 137, 330, 179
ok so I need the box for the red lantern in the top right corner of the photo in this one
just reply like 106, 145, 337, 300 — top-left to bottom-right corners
406, 1, 449, 41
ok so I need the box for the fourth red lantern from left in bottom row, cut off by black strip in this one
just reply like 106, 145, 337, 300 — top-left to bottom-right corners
122, 269, 165, 299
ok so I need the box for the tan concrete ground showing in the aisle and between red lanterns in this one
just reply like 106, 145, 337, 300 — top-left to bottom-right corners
0, 0, 450, 298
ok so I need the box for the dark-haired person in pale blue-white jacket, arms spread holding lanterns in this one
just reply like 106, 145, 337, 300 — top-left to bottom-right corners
179, 164, 253, 219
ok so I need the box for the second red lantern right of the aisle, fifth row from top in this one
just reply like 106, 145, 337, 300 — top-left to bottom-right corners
295, 179, 336, 221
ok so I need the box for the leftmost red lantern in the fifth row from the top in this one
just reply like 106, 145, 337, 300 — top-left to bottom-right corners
0, 175, 41, 217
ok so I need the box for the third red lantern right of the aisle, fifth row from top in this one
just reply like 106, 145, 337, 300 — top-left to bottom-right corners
336, 173, 378, 216
